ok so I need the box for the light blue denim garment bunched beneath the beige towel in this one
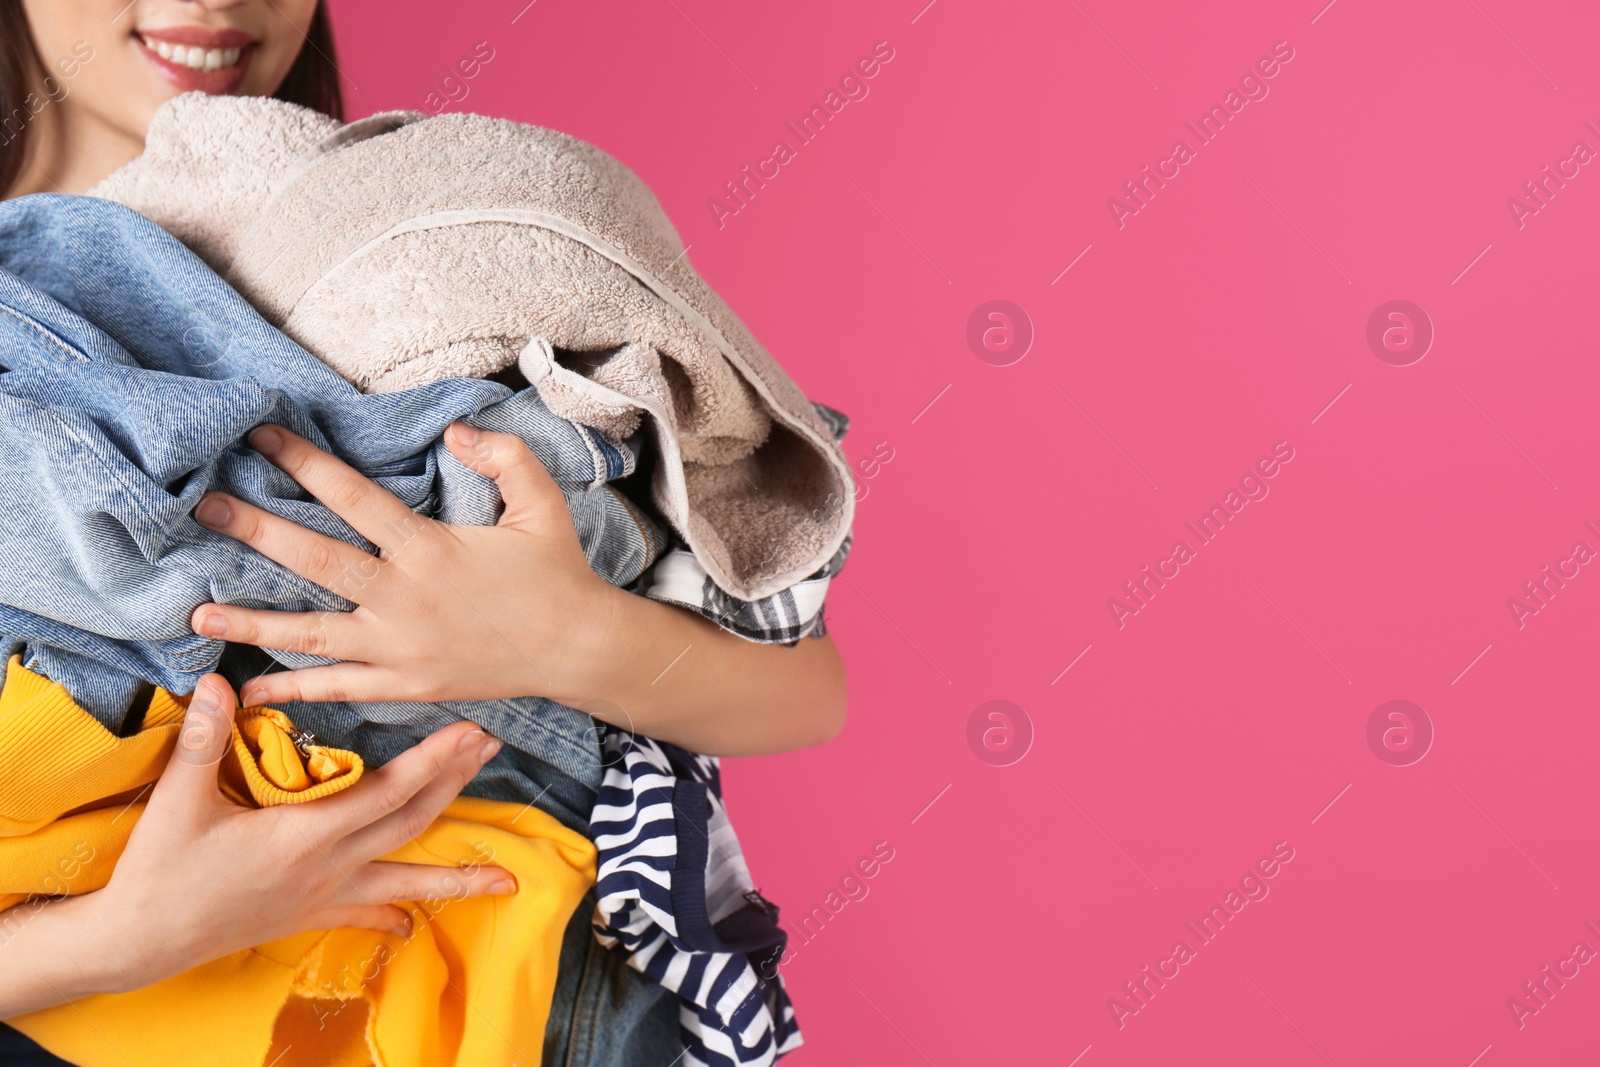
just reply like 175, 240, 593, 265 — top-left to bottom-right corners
0, 195, 664, 785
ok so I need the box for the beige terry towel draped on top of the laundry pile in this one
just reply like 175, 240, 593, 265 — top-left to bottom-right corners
93, 93, 854, 600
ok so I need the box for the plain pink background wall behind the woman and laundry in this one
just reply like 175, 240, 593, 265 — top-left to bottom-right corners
334, 0, 1600, 1067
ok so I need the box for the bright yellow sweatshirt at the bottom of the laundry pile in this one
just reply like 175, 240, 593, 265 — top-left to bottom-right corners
0, 659, 595, 1067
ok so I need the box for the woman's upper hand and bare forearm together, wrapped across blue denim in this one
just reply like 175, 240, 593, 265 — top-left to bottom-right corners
192, 422, 845, 755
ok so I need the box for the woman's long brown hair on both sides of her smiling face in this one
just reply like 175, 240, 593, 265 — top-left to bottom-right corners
0, 0, 344, 197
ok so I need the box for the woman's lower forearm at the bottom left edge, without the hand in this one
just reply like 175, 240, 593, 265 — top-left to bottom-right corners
0, 896, 123, 1019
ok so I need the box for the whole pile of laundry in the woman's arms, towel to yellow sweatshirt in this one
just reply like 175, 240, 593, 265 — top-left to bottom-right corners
0, 94, 853, 1067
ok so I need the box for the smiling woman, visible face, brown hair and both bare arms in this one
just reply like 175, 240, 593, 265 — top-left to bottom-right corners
0, 0, 845, 1062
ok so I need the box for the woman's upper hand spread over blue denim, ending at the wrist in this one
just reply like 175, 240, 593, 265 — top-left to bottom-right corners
192, 422, 627, 705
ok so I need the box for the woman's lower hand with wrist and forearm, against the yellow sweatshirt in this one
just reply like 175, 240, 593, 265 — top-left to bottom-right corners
0, 675, 517, 1017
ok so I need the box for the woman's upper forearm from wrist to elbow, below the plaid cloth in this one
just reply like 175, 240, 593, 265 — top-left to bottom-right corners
574, 593, 845, 757
